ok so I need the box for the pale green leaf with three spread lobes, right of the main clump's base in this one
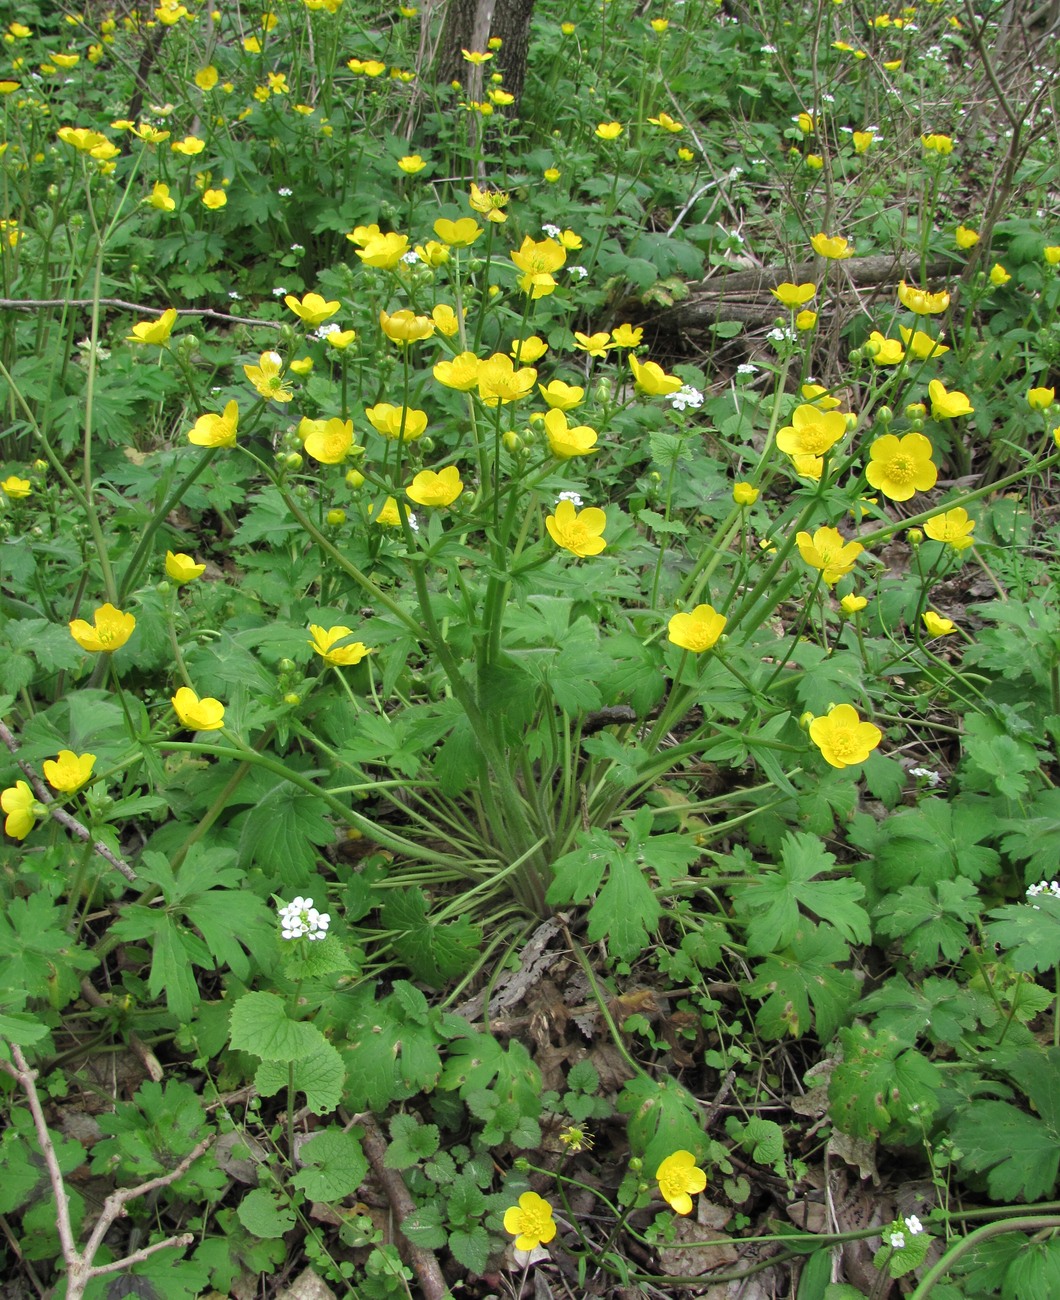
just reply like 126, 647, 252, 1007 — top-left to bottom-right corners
731, 832, 871, 957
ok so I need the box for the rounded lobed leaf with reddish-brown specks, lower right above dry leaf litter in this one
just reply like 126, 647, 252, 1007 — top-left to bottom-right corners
828, 1024, 942, 1138
